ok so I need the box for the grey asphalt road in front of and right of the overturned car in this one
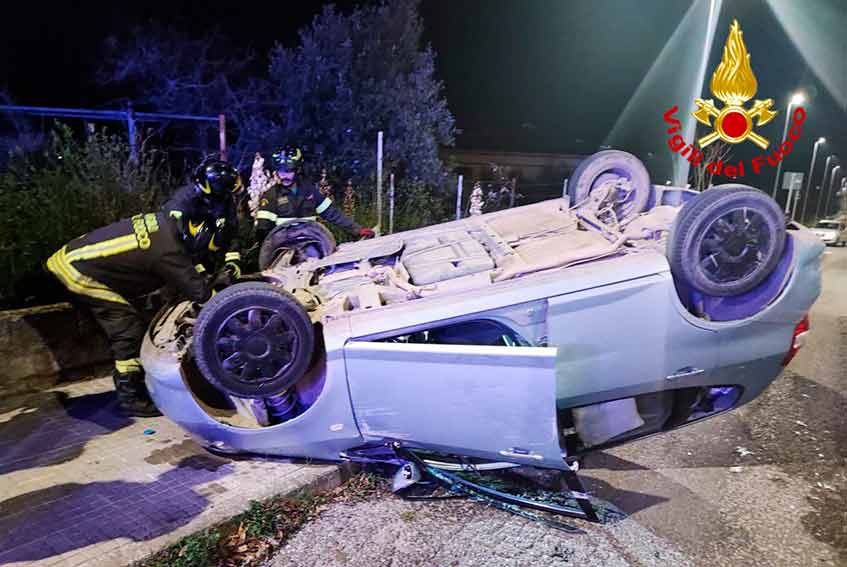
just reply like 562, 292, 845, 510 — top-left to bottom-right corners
269, 248, 847, 567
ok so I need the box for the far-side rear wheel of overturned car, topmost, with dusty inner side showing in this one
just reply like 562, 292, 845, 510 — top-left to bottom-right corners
568, 150, 652, 221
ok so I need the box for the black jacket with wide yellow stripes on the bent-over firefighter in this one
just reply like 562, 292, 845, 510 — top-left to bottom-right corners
47, 213, 211, 304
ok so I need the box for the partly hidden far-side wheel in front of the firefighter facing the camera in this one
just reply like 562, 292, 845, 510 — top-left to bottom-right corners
259, 220, 336, 270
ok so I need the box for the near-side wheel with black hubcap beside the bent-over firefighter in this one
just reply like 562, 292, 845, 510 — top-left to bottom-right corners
194, 282, 315, 398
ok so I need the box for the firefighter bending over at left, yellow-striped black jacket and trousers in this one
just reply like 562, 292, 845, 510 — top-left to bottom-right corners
47, 213, 222, 417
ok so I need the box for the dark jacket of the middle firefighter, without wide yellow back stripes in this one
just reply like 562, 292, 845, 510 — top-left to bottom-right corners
162, 185, 241, 268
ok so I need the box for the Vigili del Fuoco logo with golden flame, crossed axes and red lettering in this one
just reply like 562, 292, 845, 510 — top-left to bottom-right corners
663, 20, 806, 178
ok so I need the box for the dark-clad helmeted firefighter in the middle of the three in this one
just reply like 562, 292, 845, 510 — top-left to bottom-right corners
163, 159, 243, 279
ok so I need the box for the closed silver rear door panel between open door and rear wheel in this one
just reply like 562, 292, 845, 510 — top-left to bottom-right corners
547, 273, 717, 408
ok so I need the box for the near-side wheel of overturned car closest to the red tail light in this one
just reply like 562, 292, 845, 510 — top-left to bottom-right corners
667, 185, 786, 297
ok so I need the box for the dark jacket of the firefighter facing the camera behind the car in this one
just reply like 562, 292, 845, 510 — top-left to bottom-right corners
256, 180, 362, 234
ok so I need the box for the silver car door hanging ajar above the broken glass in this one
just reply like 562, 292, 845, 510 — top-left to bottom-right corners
344, 341, 564, 468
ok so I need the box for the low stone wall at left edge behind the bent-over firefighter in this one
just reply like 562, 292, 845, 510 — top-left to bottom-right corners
0, 303, 112, 397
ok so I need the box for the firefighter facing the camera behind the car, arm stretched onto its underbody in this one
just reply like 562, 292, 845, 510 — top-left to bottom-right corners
256, 146, 374, 242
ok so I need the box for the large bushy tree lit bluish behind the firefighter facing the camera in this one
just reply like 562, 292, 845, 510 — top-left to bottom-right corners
269, 0, 454, 184
